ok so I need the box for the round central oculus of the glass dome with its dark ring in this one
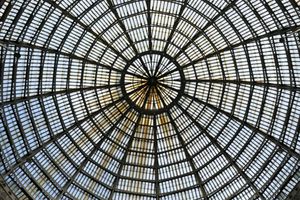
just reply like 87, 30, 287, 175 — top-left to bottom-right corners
120, 51, 185, 115
